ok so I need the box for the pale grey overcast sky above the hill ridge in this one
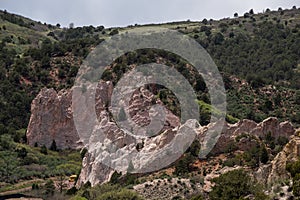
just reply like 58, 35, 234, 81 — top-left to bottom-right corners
0, 0, 300, 27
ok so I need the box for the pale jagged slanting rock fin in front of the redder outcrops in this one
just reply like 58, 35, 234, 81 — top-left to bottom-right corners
77, 116, 199, 186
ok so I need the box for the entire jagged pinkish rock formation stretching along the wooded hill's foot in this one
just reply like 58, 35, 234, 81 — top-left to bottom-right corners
27, 78, 299, 188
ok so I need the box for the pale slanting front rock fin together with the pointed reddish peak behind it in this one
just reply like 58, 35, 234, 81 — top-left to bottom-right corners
73, 74, 200, 186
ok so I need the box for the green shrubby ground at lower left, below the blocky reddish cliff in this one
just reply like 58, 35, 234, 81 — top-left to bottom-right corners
0, 133, 81, 184
